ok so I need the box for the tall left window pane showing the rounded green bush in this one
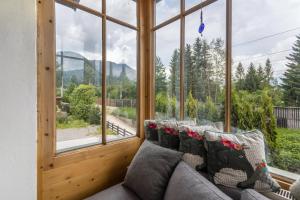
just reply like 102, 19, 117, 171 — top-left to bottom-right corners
55, 3, 101, 152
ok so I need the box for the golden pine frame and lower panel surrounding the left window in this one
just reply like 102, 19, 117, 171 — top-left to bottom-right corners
37, 0, 150, 199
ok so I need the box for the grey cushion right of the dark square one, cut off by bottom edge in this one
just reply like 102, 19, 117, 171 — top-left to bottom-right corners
164, 161, 230, 200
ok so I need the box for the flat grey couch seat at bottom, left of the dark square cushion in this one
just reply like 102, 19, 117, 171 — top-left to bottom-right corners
86, 184, 140, 200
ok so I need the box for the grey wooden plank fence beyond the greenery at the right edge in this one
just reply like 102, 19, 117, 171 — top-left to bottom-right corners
274, 107, 300, 128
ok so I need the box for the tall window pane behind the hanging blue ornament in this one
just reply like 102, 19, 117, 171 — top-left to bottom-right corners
184, 0, 226, 126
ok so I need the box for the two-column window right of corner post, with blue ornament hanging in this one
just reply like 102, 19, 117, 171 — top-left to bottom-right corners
154, 0, 226, 126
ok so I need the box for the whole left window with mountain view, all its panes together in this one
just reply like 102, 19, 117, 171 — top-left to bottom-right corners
55, 0, 138, 152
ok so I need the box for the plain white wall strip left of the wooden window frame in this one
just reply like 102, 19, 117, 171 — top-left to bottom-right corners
0, 0, 37, 200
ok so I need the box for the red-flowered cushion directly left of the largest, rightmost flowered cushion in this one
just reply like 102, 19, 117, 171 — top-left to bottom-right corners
179, 125, 219, 171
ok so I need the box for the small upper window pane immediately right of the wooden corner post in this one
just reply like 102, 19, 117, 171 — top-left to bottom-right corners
155, 0, 180, 25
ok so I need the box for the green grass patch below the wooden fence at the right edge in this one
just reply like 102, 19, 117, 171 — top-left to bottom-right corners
274, 128, 300, 174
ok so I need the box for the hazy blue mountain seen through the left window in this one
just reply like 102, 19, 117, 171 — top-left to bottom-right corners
56, 51, 137, 85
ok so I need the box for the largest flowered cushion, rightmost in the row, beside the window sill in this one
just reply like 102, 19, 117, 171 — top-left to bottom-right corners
205, 130, 280, 192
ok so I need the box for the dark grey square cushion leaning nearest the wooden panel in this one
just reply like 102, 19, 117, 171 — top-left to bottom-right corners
124, 141, 182, 200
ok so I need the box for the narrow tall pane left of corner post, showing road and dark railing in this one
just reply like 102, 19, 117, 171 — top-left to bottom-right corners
106, 22, 137, 141
